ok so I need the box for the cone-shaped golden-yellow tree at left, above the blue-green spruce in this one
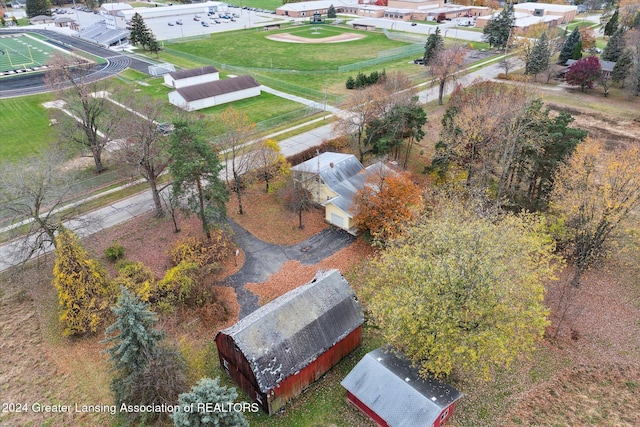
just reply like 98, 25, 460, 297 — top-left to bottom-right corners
53, 227, 113, 336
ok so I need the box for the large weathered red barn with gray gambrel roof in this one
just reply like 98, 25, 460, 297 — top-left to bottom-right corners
216, 270, 364, 415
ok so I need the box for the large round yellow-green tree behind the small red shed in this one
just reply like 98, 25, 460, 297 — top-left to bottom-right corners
364, 206, 557, 379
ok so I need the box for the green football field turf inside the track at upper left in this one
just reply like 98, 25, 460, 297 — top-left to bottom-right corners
0, 35, 54, 71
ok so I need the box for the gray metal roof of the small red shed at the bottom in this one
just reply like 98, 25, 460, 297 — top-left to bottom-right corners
340, 348, 462, 427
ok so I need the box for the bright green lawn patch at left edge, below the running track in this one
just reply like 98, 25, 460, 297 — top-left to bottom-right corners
0, 94, 56, 161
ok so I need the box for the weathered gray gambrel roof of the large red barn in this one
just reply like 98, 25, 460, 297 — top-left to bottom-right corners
219, 270, 364, 393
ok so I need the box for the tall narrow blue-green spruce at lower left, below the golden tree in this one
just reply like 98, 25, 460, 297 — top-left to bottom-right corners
104, 287, 163, 406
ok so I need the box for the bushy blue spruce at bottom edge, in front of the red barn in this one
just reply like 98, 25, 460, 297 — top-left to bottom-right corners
171, 378, 249, 427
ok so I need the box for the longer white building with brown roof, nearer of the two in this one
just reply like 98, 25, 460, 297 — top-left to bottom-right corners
169, 75, 261, 111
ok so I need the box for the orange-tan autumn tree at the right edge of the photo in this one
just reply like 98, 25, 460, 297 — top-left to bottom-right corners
552, 140, 640, 287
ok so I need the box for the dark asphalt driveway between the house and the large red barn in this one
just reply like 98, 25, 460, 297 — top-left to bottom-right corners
222, 219, 355, 319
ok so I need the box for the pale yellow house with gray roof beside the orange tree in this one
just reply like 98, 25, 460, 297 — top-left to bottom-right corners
291, 152, 393, 234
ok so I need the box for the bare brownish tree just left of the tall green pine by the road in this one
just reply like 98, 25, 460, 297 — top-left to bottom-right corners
116, 94, 169, 217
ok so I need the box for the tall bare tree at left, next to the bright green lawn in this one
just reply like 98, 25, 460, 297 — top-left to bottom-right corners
45, 55, 124, 173
